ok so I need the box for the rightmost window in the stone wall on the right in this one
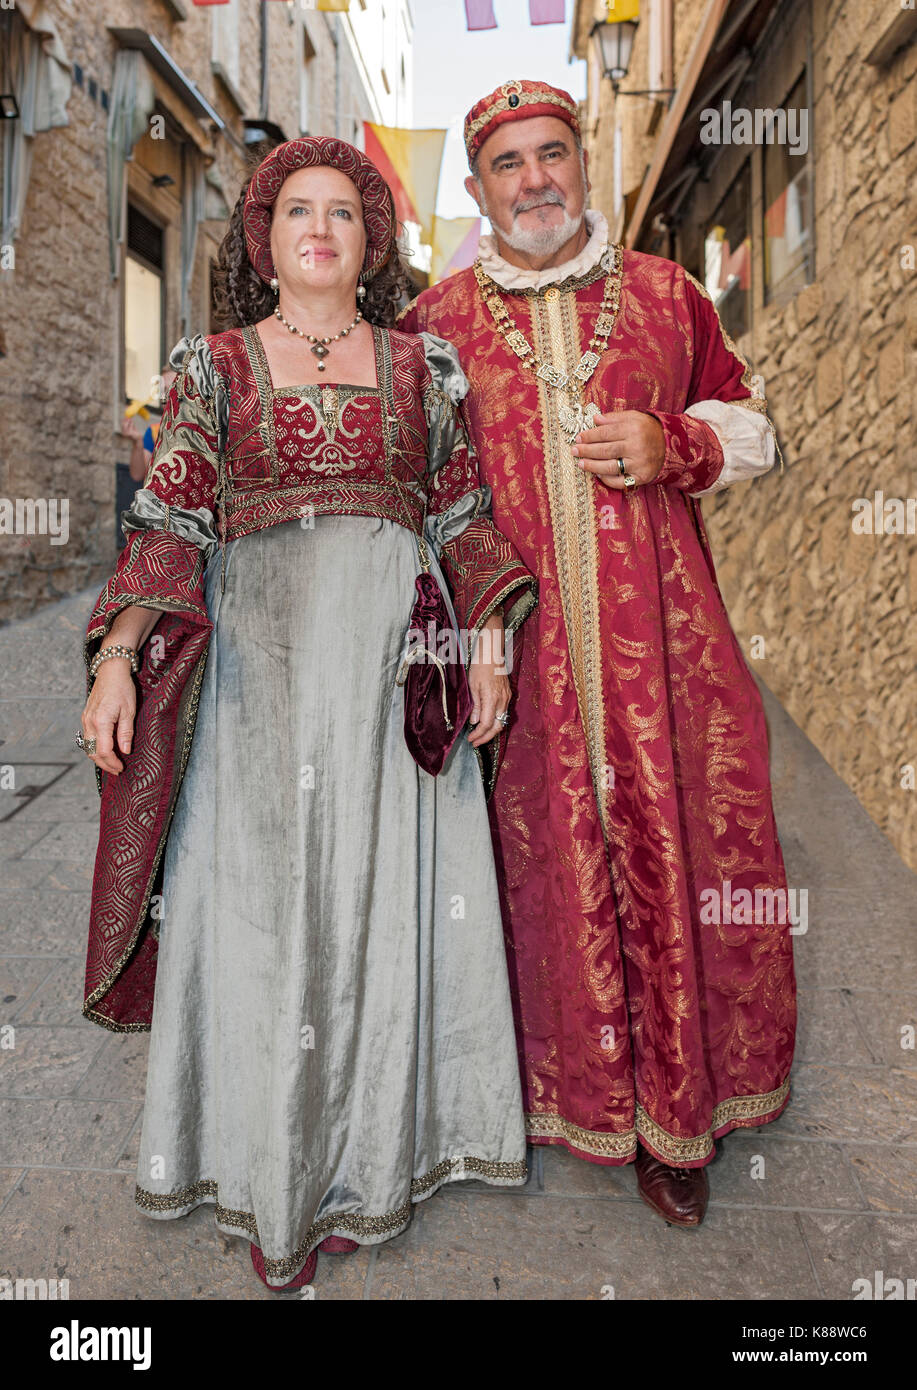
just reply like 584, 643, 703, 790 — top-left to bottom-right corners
764, 72, 813, 302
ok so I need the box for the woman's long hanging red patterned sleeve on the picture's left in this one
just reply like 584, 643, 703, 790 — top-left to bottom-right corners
83, 339, 220, 1031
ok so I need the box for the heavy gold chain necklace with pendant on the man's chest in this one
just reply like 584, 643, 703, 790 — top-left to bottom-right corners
474, 245, 624, 445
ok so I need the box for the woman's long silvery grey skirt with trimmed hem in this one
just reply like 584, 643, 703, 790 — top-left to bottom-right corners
136, 516, 527, 1286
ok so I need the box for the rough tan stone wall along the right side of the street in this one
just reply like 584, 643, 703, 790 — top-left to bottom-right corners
578, 0, 917, 869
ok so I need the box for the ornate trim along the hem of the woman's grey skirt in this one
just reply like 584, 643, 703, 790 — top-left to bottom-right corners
133, 1156, 528, 1279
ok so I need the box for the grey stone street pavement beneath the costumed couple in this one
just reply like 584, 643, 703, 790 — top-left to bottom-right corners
0, 589, 917, 1300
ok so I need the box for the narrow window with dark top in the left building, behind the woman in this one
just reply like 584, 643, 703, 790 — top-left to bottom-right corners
124, 203, 165, 402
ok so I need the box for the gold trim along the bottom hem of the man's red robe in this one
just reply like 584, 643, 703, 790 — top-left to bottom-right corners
525, 1077, 789, 1168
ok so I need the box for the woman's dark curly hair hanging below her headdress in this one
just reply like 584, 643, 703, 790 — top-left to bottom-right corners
214, 167, 415, 332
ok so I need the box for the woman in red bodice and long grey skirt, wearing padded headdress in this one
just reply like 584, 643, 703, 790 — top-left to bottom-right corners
78, 138, 535, 1289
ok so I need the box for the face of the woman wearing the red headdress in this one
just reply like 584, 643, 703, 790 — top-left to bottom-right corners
271, 165, 367, 295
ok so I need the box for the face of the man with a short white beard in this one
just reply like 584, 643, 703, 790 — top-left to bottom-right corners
465, 115, 589, 256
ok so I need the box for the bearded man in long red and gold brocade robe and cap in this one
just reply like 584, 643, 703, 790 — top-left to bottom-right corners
402, 82, 796, 1225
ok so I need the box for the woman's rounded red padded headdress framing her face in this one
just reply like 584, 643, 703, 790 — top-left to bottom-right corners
242, 135, 396, 281
